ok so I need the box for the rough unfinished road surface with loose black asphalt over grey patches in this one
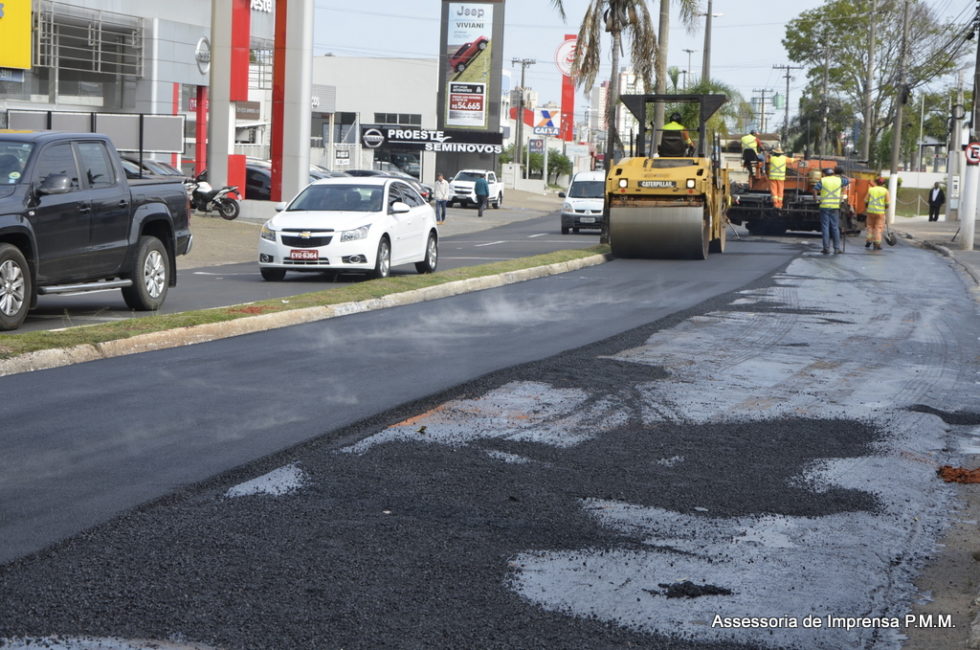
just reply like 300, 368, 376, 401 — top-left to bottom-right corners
0, 195, 980, 650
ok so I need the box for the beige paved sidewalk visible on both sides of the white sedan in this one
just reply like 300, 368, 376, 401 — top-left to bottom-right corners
177, 190, 562, 269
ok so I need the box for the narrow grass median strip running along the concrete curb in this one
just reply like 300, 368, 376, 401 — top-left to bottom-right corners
0, 246, 609, 360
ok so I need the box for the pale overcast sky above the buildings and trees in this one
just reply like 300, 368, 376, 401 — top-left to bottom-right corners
313, 0, 975, 124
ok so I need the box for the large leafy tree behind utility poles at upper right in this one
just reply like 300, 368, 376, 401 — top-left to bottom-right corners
783, 0, 964, 165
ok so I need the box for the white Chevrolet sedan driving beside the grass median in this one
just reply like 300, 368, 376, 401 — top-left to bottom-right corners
259, 176, 439, 280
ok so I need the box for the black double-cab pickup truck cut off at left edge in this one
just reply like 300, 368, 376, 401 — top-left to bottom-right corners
0, 129, 193, 330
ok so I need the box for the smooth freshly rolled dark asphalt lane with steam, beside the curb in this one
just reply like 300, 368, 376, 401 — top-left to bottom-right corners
0, 237, 799, 561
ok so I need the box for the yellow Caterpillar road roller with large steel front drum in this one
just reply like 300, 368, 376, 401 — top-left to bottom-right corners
605, 95, 731, 260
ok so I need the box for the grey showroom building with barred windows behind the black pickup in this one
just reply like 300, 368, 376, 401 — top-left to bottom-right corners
0, 0, 275, 167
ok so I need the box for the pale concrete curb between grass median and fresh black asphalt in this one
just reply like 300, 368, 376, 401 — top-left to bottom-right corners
0, 255, 609, 377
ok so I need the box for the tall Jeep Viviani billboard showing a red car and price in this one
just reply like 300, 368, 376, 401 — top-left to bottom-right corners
445, 2, 494, 128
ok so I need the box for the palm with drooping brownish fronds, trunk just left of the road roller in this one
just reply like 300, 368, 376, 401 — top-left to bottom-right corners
551, 0, 660, 170
